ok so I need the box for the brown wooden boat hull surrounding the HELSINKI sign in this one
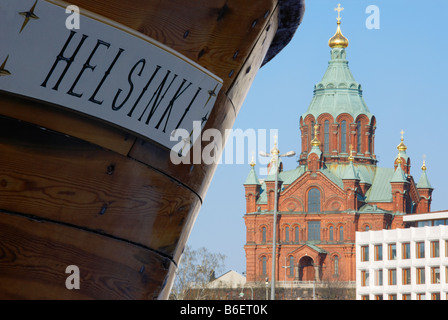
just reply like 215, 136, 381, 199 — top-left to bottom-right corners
0, 0, 304, 299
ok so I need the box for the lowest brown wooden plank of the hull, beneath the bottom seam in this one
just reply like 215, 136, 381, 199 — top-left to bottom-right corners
0, 212, 172, 300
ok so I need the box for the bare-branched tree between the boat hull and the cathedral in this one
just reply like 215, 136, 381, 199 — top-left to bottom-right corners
170, 246, 225, 300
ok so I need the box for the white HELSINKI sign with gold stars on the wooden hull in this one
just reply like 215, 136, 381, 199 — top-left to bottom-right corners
0, 0, 222, 154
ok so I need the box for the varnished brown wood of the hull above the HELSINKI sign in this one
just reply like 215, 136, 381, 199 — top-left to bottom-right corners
66, 0, 277, 92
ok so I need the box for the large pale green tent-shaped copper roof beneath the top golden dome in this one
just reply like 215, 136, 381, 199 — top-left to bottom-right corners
302, 48, 372, 120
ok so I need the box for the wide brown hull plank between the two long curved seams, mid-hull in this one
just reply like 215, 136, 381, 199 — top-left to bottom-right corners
0, 117, 201, 257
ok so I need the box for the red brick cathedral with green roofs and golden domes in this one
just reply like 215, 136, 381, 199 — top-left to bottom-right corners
244, 13, 433, 282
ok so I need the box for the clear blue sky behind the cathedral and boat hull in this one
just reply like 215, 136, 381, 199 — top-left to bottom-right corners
188, 0, 448, 273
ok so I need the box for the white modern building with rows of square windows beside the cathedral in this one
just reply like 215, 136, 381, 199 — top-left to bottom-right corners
356, 211, 448, 300
